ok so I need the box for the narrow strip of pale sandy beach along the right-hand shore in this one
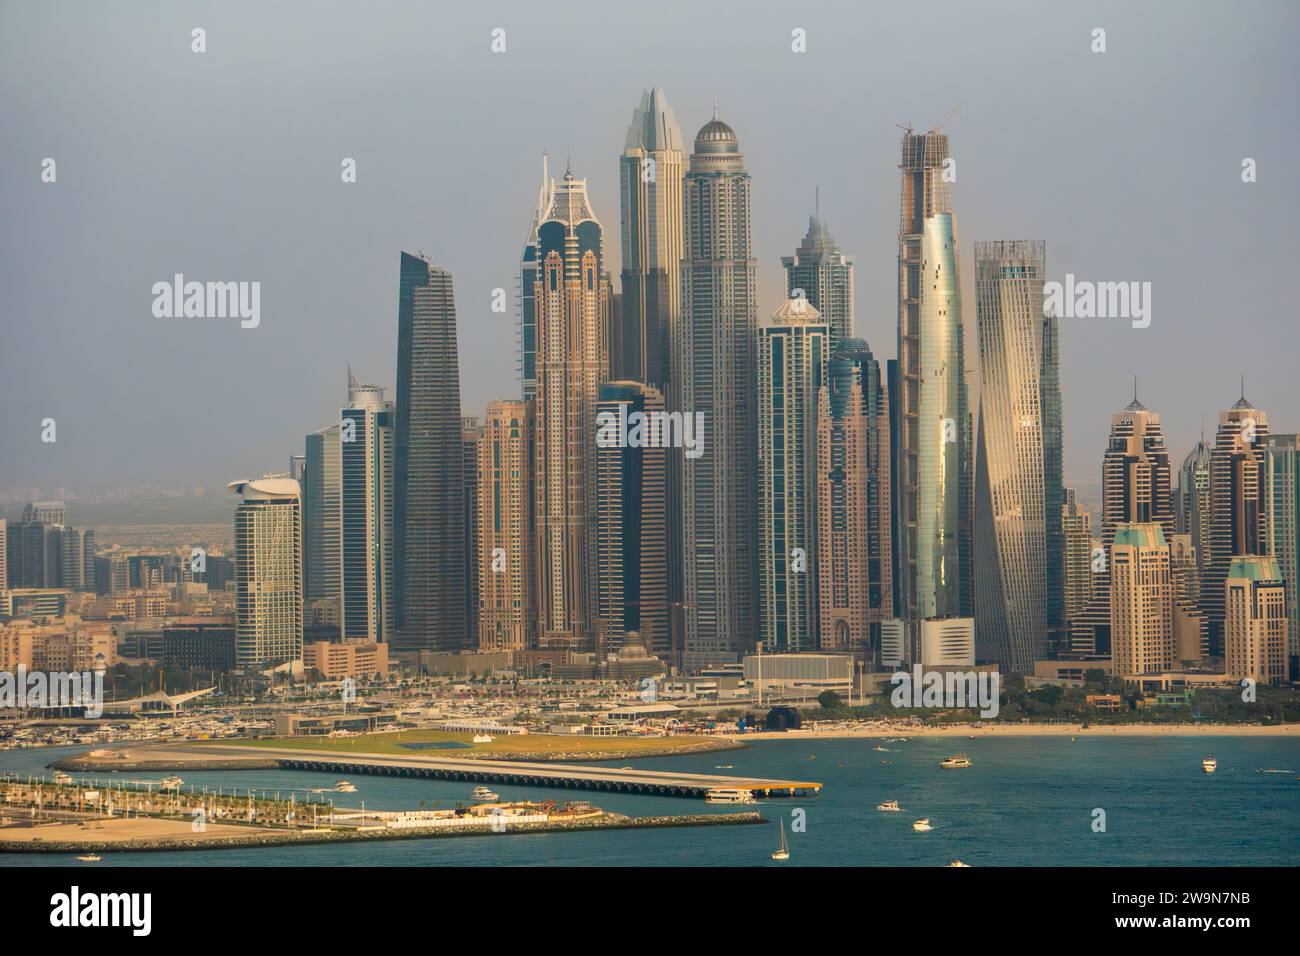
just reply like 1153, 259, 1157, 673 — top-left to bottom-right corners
728, 721, 1300, 740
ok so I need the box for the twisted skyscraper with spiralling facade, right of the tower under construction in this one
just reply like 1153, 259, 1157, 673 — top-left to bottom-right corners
975, 242, 1060, 672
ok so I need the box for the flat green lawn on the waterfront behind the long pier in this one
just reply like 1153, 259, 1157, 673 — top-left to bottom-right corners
211, 730, 714, 757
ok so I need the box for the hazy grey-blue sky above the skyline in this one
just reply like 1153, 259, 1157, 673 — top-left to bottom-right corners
0, 0, 1300, 509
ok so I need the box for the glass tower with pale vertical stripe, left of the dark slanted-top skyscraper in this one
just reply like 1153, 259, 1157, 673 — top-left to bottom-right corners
338, 369, 394, 643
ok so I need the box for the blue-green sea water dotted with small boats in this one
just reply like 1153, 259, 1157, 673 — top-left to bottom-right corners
0, 736, 1300, 866
